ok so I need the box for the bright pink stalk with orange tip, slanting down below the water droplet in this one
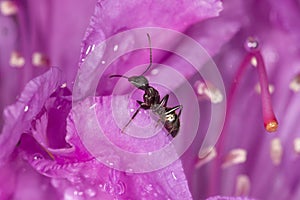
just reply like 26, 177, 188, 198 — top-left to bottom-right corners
253, 51, 278, 132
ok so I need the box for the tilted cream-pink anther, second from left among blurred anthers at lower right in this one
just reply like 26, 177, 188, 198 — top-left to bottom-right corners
222, 149, 247, 168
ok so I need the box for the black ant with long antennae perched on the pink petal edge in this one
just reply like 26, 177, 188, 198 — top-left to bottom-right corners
109, 33, 183, 138
